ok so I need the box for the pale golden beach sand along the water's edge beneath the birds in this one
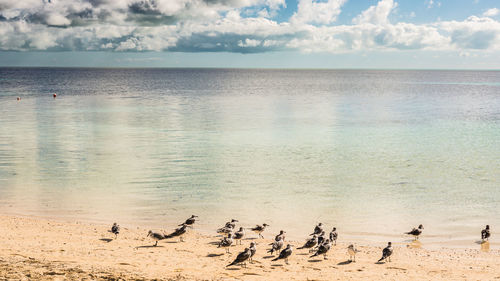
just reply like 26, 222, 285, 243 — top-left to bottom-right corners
0, 215, 500, 280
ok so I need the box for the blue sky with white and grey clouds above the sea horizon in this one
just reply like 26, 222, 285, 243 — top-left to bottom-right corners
0, 0, 500, 69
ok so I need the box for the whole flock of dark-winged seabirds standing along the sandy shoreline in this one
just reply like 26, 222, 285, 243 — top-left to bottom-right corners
109, 215, 491, 267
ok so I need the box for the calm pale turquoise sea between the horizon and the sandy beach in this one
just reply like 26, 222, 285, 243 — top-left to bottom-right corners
0, 68, 500, 248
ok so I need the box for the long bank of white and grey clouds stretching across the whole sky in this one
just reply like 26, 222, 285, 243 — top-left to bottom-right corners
0, 0, 500, 54
